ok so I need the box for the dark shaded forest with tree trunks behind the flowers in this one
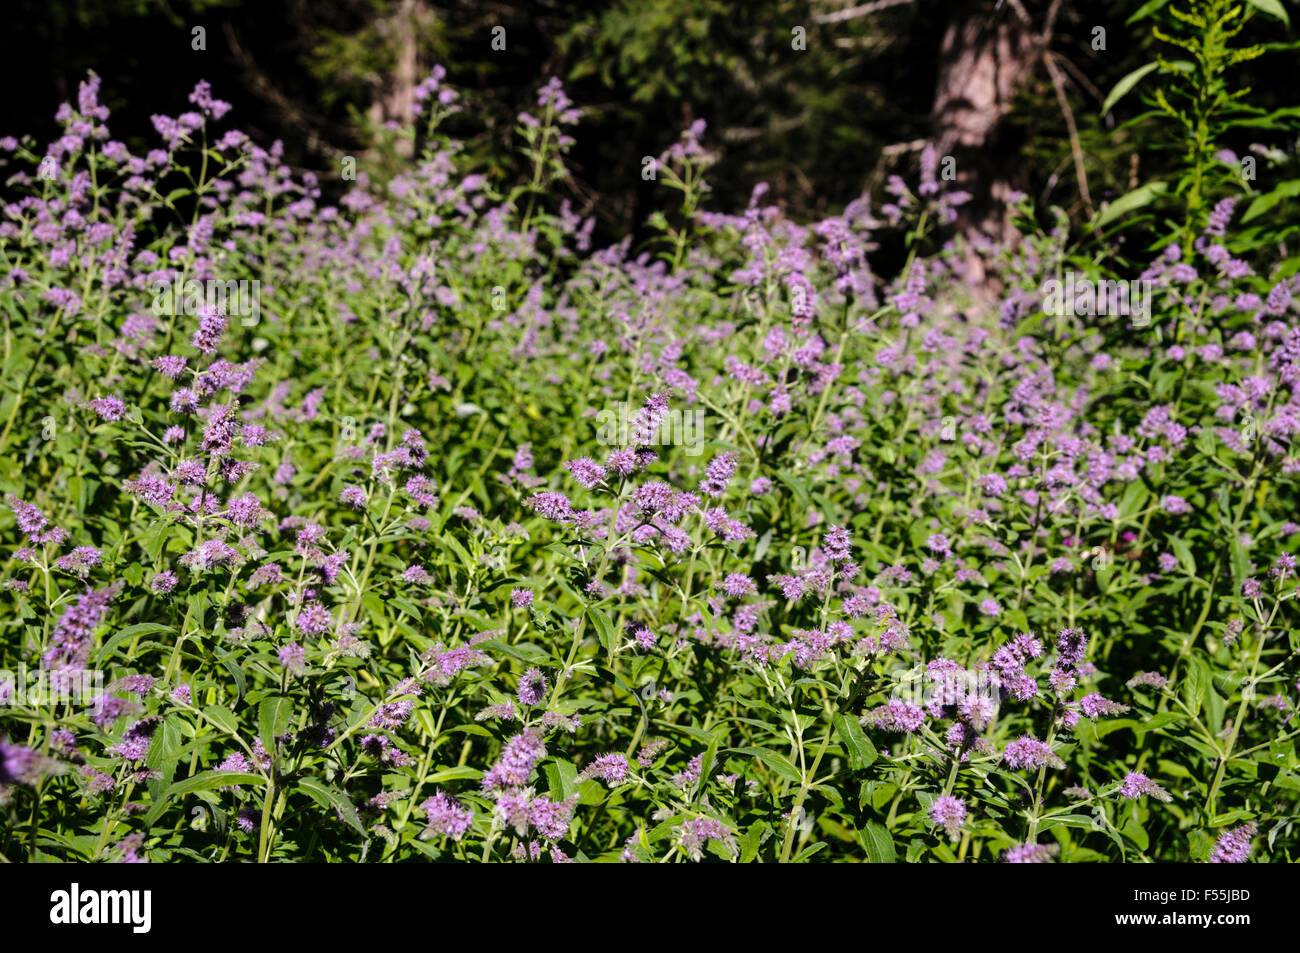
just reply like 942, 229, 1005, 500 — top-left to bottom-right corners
0, 0, 1300, 252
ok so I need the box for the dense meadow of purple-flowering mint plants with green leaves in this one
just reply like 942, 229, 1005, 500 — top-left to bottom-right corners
0, 40, 1300, 863
